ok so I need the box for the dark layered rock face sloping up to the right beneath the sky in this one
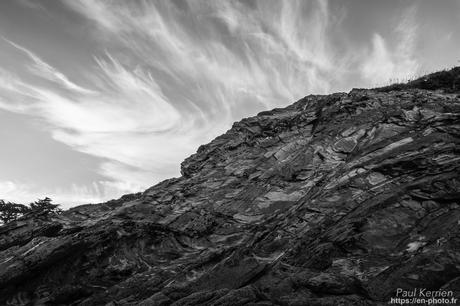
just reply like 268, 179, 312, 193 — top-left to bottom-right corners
0, 68, 460, 306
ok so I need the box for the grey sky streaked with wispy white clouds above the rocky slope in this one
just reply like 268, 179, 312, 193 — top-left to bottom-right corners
0, 0, 460, 208
